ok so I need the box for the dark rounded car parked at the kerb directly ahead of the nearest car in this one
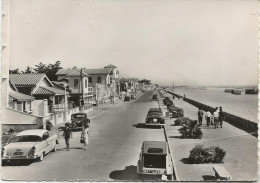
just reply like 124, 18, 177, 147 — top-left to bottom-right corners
145, 108, 165, 127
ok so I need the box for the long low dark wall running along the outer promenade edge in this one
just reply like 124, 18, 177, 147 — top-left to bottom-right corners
167, 91, 258, 137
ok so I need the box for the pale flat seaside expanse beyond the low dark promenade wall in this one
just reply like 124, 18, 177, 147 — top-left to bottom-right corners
169, 87, 258, 123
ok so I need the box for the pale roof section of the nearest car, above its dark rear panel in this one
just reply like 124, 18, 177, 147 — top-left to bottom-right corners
142, 141, 167, 155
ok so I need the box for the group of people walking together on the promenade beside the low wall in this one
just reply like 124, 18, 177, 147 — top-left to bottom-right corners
198, 107, 225, 128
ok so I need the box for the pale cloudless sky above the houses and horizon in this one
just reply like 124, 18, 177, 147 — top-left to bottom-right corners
9, 0, 258, 86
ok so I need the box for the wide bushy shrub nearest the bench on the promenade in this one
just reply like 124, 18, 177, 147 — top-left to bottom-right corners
189, 145, 226, 164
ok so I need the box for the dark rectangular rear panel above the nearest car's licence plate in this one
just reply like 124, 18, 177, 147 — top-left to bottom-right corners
144, 154, 166, 168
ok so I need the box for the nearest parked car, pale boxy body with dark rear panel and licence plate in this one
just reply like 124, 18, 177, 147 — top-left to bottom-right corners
137, 141, 173, 180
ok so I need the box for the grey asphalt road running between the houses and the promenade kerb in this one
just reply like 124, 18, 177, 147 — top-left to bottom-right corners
2, 91, 165, 181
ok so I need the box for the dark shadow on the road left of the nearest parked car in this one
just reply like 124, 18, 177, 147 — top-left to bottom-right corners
109, 165, 139, 181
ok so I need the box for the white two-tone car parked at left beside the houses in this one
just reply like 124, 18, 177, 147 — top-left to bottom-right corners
2, 129, 57, 161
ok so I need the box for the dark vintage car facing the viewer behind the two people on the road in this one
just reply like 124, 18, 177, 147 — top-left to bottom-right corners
71, 113, 90, 130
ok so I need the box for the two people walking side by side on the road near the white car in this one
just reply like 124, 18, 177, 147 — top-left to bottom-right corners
63, 121, 89, 151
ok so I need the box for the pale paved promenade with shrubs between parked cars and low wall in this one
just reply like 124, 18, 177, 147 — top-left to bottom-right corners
159, 91, 258, 181
